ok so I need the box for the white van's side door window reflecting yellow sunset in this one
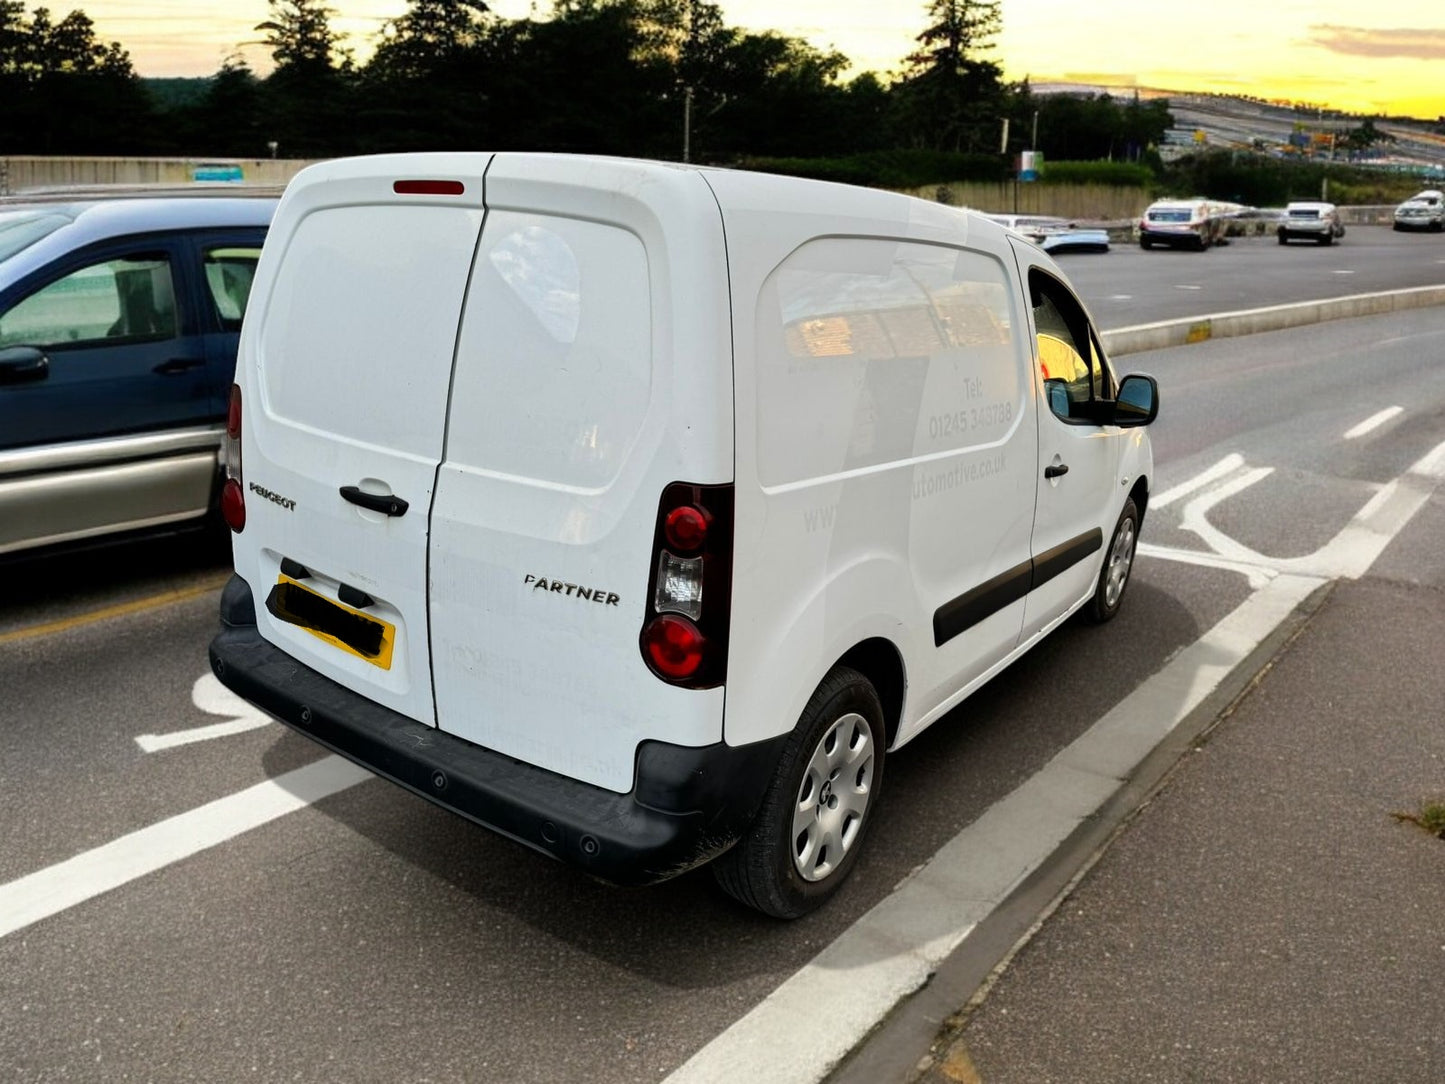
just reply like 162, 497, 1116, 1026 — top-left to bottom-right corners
1029, 269, 1114, 422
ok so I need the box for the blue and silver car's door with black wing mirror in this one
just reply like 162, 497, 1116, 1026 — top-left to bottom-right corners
0, 236, 221, 552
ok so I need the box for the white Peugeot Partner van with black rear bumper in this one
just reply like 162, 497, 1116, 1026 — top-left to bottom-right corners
211, 153, 1157, 916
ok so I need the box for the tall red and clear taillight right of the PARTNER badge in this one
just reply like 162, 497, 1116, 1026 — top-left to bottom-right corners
640, 481, 733, 689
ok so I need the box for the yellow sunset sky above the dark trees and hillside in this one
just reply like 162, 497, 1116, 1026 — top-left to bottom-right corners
73, 0, 1445, 119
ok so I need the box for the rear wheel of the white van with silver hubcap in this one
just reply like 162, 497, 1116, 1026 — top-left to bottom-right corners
712, 666, 887, 918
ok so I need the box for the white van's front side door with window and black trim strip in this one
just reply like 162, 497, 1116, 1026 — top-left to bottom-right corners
1017, 246, 1126, 640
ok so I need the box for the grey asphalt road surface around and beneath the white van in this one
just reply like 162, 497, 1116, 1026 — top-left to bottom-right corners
0, 286, 1445, 1084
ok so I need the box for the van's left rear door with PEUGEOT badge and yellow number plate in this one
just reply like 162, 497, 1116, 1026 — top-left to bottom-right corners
236, 155, 490, 724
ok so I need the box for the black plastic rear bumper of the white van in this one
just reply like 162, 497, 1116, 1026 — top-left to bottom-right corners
211, 577, 786, 885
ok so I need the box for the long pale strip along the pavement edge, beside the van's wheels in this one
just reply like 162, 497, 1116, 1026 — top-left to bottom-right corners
665, 575, 1325, 1084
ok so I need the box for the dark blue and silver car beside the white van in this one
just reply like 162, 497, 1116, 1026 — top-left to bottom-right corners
0, 195, 276, 555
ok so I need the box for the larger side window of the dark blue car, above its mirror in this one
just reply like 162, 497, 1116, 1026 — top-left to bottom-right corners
0, 253, 176, 347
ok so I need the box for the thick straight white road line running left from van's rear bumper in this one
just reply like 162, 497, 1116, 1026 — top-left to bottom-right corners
0, 756, 373, 937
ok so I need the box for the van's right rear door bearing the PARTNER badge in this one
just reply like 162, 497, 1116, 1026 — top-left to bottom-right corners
431, 155, 733, 792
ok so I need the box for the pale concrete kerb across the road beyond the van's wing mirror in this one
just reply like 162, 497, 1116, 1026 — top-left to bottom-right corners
1100, 285, 1445, 357
